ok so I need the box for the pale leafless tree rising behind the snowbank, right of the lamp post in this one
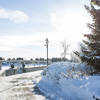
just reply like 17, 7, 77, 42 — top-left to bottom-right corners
61, 40, 70, 62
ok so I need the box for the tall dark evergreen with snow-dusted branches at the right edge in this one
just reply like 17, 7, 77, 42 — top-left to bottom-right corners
74, 0, 100, 73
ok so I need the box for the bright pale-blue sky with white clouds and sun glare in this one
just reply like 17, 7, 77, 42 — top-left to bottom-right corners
0, 0, 90, 59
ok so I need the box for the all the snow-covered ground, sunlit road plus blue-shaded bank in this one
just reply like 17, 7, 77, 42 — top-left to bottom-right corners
0, 62, 100, 100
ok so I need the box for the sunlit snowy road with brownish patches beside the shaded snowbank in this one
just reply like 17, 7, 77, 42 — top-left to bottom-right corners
0, 71, 45, 100
